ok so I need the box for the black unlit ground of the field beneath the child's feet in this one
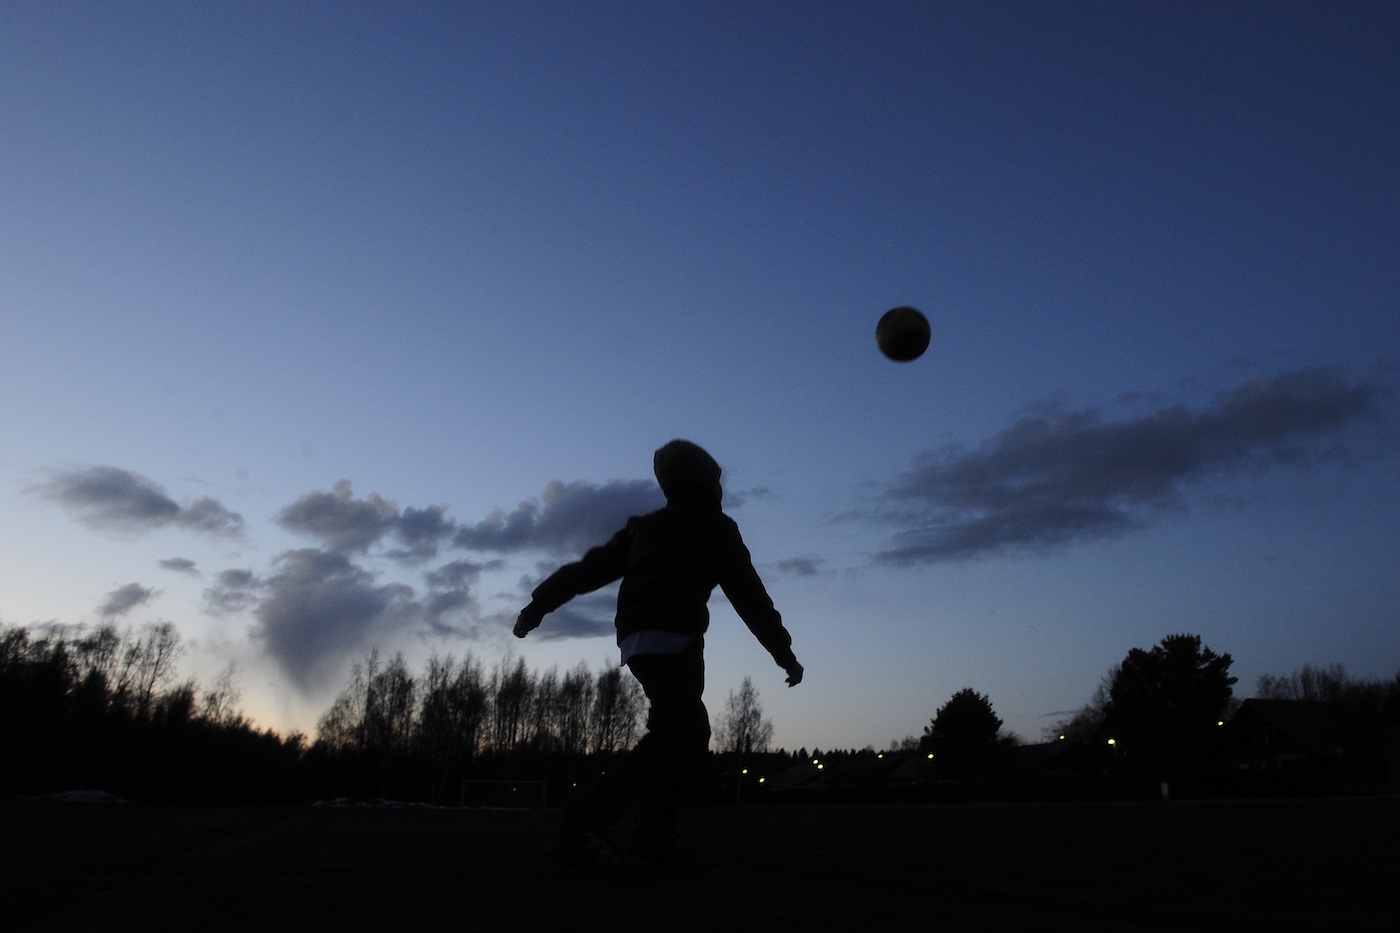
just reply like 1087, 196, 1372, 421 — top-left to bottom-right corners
0, 797, 1400, 933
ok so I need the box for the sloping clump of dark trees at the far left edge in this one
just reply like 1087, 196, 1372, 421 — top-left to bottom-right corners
0, 622, 304, 801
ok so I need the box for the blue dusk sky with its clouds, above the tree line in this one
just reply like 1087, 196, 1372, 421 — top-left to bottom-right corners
0, 3, 1400, 748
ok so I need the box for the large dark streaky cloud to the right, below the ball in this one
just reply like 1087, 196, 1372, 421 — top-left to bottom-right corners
878, 370, 1385, 565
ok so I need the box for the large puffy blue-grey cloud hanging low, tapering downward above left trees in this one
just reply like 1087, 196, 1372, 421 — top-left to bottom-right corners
252, 548, 421, 691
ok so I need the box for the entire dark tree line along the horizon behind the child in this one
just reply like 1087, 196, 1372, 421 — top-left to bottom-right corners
0, 622, 1400, 806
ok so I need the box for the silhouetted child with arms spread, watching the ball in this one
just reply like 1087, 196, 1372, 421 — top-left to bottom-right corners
515, 440, 802, 871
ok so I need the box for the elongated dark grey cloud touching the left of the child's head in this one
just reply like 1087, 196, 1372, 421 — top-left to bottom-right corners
452, 479, 665, 553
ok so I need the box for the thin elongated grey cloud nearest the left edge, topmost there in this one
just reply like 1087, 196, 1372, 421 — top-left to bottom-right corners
34, 467, 244, 538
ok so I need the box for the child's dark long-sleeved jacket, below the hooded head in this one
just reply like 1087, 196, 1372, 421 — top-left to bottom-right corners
531, 499, 797, 668
